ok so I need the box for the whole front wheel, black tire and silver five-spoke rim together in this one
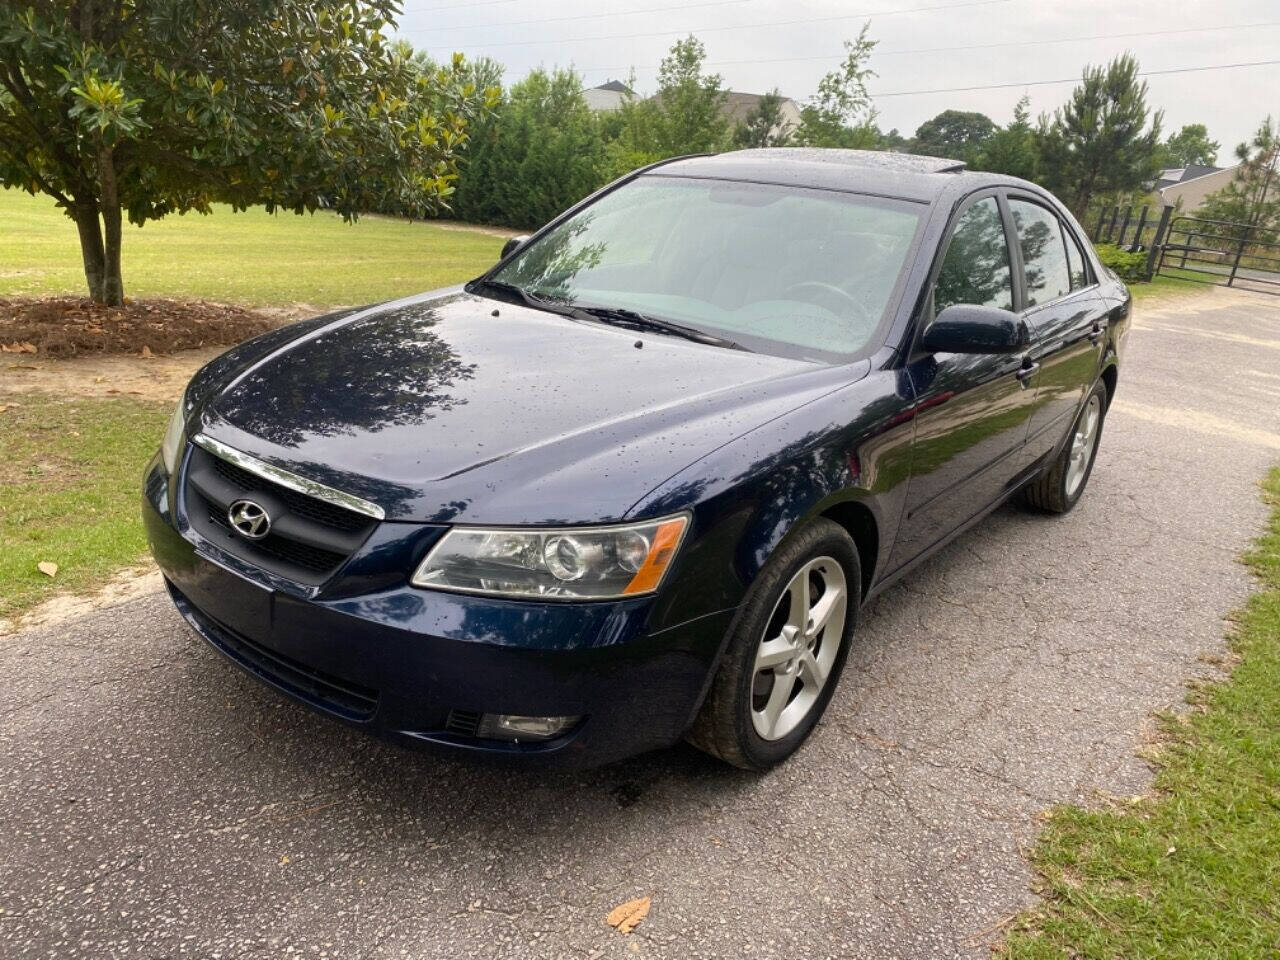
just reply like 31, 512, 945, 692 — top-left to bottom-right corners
689, 520, 861, 769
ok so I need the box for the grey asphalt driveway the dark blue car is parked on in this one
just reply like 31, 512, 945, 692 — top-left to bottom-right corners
0, 284, 1280, 960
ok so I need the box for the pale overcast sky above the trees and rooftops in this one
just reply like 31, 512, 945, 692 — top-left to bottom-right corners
401, 0, 1280, 161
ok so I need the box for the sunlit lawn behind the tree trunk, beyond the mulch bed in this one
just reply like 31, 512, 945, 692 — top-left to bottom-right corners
0, 189, 503, 307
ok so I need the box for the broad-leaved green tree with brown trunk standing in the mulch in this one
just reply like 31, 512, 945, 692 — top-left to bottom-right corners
0, 0, 498, 306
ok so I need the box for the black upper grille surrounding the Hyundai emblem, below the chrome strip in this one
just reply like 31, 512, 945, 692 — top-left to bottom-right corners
184, 445, 376, 586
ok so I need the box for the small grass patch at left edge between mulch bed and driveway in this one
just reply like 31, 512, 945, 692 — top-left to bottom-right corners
0, 394, 169, 617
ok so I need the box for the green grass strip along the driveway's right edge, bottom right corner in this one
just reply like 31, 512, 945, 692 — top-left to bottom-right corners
1005, 468, 1280, 960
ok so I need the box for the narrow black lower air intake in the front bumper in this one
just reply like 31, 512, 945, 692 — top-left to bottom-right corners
165, 581, 378, 721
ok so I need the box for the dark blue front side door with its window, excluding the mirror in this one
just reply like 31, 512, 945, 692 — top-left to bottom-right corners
890, 191, 1036, 570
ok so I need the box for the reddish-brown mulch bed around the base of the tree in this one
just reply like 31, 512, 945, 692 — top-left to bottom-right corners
0, 297, 280, 357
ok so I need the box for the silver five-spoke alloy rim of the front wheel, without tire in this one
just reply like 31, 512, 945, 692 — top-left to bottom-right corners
751, 557, 849, 740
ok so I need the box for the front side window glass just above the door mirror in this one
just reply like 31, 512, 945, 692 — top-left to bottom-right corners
933, 197, 1014, 312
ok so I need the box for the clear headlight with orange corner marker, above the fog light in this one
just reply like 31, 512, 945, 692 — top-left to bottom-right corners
412, 516, 689, 600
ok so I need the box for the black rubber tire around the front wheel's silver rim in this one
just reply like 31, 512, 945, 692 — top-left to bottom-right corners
686, 520, 861, 771
